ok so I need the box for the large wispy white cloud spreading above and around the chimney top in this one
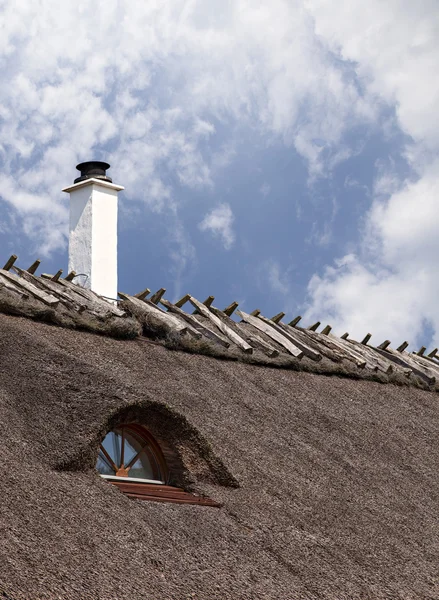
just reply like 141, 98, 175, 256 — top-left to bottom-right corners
0, 0, 382, 252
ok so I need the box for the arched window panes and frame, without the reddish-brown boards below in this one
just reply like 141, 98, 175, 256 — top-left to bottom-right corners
96, 423, 167, 483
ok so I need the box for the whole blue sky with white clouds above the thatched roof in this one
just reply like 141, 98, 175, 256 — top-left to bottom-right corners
0, 0, 439, 349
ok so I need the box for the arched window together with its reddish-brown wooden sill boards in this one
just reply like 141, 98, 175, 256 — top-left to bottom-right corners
96, 423, 220, 506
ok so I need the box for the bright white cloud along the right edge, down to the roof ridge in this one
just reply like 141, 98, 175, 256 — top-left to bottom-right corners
306, 0, 439, 345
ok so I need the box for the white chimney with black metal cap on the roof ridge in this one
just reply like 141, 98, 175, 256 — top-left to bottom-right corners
63, 161, 124, 299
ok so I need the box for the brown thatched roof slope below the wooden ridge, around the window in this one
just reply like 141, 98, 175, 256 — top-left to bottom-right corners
0, 315, 439, 600
